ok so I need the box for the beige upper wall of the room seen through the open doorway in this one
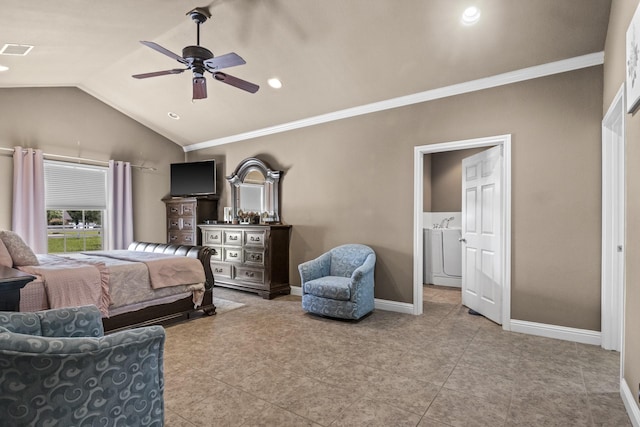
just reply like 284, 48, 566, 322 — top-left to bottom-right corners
424, 148, 486, 212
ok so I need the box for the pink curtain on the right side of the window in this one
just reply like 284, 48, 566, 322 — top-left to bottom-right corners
106, 160, 133, 249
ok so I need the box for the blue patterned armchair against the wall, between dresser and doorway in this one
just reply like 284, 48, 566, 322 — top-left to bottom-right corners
298, 244, 376, 319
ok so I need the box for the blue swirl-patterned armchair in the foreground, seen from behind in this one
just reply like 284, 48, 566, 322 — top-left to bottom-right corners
0, 306, 165, 426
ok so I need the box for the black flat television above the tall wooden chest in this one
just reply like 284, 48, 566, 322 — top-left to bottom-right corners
171, 160, 216, 197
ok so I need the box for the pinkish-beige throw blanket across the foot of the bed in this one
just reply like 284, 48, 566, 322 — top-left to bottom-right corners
86, 250, 206, 289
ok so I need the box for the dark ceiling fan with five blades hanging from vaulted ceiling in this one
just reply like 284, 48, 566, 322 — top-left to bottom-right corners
132, 7, 260, 99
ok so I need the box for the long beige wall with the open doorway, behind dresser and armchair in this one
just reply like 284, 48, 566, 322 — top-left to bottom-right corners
188, 67, 602, 330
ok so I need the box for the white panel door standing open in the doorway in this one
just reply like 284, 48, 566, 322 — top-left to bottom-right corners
461, 146, 503, 324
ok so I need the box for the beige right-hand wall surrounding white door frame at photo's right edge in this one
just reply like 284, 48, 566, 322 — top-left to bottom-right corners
603, 0, 640, 414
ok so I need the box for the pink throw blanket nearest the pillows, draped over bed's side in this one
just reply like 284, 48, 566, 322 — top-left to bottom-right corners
20, 255, 111, 317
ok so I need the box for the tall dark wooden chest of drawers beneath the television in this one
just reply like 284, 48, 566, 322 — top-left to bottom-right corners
162, 197, 218, 245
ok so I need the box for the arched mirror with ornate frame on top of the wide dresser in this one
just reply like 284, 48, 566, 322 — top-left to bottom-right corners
227, 157, 282, 223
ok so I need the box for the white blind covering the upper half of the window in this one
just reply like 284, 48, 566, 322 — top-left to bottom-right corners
44, 160, 107, 210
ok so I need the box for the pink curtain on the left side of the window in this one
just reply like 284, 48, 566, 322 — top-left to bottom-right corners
12, 147, 47, 254
